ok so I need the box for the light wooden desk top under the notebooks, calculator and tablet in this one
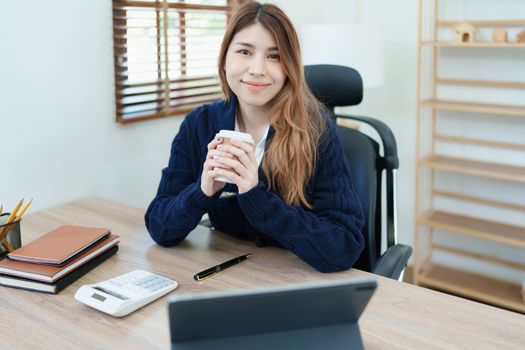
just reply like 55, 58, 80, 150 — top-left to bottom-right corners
0, 199, 525, 350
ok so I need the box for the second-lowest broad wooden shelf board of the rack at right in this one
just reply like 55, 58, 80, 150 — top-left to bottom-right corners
418, 210, 525, 248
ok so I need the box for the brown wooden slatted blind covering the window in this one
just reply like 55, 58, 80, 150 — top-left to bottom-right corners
113, 0, 229, 123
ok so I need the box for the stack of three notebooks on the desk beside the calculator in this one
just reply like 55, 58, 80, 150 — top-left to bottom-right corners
0, 225, 119, 294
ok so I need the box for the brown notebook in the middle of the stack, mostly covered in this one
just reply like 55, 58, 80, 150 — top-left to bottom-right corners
0, 235, 119, 283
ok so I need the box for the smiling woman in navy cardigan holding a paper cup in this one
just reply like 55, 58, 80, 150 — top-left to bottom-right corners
146, 2, 364, 272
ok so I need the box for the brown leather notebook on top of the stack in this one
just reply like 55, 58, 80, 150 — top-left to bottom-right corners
7, 225, 110, 266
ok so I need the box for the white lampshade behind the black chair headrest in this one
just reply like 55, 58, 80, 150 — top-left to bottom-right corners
301, 24, 384, 88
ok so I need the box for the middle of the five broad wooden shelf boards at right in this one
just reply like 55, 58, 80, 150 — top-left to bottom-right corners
419, 156, 525, 182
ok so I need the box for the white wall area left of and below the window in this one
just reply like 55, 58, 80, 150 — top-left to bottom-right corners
0, 0, 181, 211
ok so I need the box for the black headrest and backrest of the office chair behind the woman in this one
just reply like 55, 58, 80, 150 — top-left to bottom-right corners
304, 65, 392, 271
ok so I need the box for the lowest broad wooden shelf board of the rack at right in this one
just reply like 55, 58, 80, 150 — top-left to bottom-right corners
418, 264, 525, 312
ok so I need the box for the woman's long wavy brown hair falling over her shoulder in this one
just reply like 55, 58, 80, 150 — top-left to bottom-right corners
218, 2, 326, 209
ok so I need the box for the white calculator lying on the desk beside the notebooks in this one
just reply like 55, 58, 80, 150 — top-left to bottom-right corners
75, 270, 177, 317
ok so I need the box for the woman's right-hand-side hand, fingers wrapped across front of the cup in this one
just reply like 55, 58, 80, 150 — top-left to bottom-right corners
214, 140, 259, 194
